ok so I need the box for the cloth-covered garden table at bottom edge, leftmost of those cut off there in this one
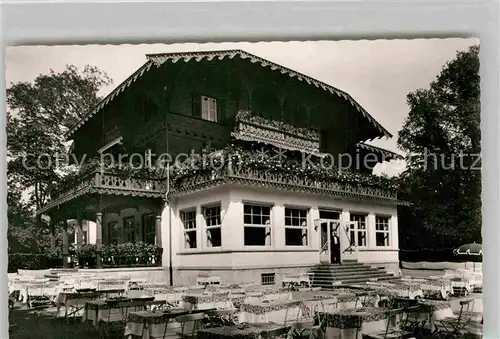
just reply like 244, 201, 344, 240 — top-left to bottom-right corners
125, 309, 189, 339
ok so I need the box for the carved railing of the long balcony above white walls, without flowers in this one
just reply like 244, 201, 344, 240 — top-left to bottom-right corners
172, 167, 397, 203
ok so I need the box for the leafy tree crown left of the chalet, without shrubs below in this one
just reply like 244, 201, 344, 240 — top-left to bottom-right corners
7, 66, 112, 209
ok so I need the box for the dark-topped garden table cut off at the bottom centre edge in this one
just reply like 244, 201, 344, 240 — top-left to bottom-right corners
197, 323, 290, 339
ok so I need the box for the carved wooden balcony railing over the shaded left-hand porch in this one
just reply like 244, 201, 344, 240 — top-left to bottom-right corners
37, 170, 166, 214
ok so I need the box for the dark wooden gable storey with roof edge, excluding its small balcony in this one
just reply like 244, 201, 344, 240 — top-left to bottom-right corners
68, 51, 396, 171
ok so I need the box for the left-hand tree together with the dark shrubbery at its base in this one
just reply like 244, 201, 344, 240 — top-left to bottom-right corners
6, 66, 112, 253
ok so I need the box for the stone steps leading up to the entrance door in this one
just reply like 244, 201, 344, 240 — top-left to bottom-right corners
308, 261, 399, 289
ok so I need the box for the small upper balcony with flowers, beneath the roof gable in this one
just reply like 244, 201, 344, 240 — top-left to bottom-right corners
231, 111, 320, 154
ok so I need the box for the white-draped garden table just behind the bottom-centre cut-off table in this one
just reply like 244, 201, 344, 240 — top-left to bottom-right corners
238, 299, 302, 324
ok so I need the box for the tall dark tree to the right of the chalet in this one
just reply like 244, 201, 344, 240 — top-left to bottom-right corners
398, 46, 481, 248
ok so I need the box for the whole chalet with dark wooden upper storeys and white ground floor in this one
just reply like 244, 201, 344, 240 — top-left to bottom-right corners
37, 50, 400, 285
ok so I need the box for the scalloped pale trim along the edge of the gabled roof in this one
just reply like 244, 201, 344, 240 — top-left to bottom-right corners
66, 50, 392, 138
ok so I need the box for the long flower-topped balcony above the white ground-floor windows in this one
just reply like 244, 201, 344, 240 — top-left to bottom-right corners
170, 150, 404, 204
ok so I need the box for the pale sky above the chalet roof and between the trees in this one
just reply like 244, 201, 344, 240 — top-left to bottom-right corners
5, 38, 479, 175
